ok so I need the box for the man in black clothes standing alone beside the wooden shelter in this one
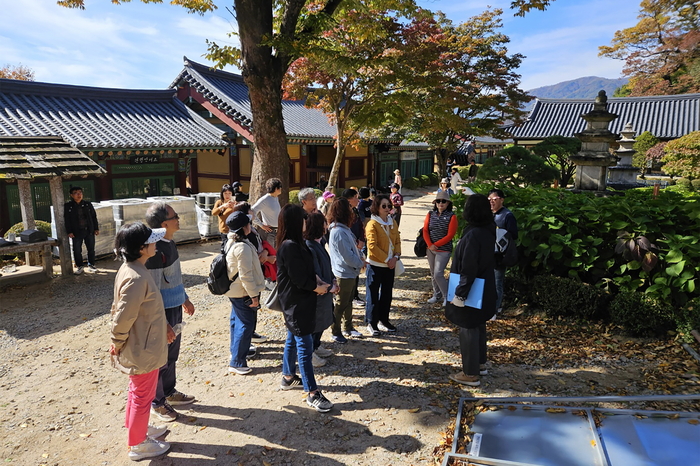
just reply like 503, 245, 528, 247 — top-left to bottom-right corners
63, 186, 100, 275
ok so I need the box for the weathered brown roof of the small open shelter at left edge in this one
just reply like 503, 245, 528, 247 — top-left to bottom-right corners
0, 136, 106, 179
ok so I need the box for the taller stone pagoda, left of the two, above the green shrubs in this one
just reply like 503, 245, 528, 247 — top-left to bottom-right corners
569, 91, 619, 191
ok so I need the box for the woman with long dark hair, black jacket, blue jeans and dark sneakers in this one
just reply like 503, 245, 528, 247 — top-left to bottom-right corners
277, 204, 333, 413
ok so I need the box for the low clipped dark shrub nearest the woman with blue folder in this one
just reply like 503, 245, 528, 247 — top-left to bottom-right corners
530, 275, 609, 319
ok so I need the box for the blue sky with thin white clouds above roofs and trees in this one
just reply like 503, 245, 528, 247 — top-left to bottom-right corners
0, 0, 639, 89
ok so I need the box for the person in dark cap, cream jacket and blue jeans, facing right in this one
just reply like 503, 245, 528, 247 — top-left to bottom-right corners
225, 210, 265, 375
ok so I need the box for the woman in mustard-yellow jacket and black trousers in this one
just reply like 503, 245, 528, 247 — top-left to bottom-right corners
365, 194, 401, 336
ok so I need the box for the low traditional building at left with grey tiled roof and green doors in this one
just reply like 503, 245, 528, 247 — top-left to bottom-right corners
0, 79, 229, 230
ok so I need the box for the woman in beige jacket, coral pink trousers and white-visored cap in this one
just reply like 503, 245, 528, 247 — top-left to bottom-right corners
109, 222, 175, 460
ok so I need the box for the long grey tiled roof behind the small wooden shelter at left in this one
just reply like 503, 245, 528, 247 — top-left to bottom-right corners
0, 79, 227, 149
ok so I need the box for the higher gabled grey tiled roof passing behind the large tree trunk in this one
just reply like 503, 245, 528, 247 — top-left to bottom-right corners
170, 57, 336, 143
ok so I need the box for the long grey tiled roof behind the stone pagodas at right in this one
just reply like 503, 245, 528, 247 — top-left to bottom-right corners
509, 94, 700, 140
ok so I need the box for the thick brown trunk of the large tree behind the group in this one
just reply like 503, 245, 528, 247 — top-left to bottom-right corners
235, 0, 289, 205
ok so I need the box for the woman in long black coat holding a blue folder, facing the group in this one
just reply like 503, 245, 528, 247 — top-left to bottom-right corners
445, 194, 496, 387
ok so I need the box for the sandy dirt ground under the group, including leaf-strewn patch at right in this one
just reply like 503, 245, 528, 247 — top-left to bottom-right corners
0, 187, 699, 466
